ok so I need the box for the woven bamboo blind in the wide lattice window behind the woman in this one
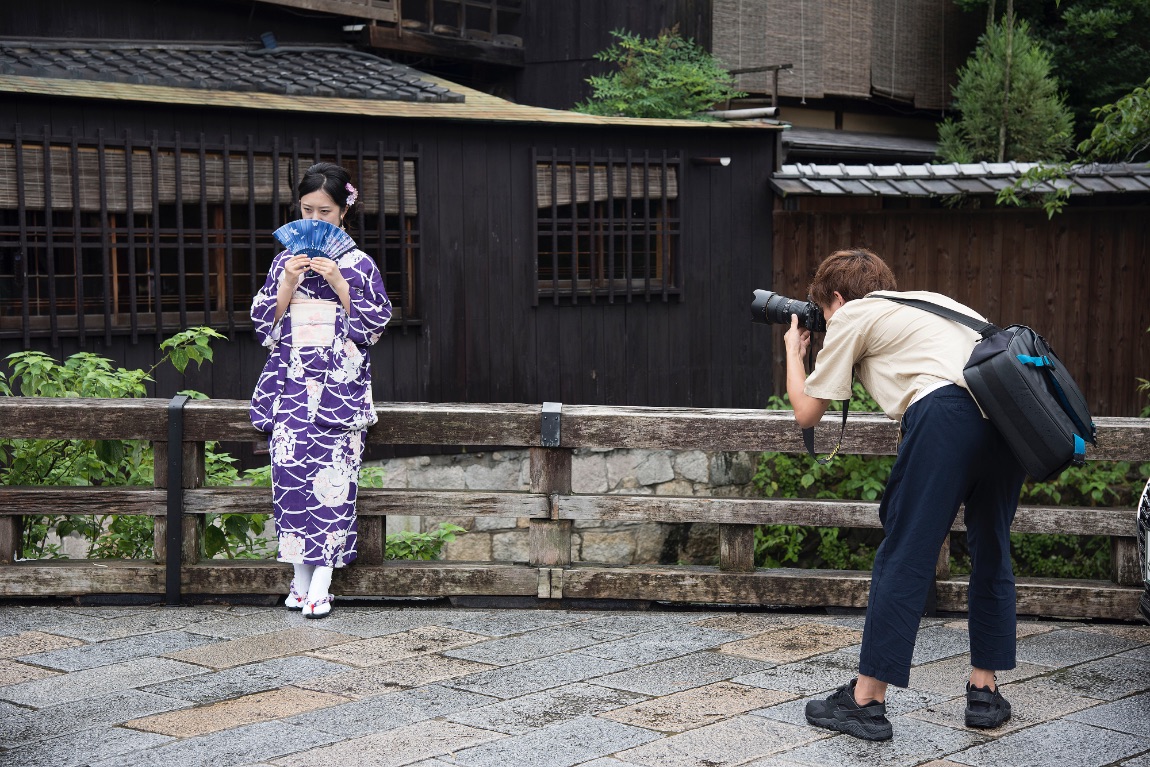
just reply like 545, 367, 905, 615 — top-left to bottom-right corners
0, 143, 419, 215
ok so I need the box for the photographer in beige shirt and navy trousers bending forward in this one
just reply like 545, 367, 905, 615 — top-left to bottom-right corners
784, 248, 1025, 741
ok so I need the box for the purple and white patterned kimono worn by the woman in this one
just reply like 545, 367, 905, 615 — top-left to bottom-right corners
251, 250, 391, 567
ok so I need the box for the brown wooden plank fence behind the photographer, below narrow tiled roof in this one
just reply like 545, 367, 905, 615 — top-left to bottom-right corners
772, 206, 1150, 416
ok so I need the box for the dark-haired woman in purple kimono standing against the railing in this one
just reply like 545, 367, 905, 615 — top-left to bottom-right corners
251, 162, 391, 618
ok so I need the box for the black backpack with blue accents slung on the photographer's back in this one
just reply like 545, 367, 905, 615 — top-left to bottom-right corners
880, 296, 1096, 482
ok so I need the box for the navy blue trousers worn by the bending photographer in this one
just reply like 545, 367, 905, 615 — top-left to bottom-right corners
859, 385, 1026, 687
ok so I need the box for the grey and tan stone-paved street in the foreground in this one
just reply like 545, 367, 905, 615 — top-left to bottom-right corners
0, 601, 1150, 767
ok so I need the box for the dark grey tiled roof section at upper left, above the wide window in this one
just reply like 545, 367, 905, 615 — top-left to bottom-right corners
0, 40, 463, 103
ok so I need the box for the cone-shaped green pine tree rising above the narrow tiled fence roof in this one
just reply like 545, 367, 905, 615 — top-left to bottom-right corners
938, 14, 1074, 162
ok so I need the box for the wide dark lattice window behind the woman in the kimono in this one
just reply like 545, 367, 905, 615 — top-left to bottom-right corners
0, 135, 420, 339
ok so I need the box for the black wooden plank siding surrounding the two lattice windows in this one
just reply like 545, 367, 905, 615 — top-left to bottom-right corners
0, 94, 774, 425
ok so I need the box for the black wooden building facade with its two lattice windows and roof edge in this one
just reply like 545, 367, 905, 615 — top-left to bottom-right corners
0, 59, 775, 423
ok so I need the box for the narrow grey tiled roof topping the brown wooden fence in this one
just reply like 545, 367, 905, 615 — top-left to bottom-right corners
771, 162, 1150, 197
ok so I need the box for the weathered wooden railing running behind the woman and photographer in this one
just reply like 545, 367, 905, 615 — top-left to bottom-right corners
0, 397, 1150, 619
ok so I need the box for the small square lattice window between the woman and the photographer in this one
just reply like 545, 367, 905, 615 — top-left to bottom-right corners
535, 152, 680, 304
